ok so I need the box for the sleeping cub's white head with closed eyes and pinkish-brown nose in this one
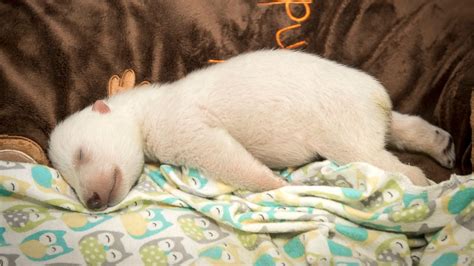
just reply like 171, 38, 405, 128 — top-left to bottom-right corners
48, 100, 144, 210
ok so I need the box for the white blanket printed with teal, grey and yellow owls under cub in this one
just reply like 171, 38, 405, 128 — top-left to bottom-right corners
0, 161, 474, 265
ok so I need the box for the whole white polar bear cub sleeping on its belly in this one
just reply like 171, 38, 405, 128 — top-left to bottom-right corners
49, 50, 454, 210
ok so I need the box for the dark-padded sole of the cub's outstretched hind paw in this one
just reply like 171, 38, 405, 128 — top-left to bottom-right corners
431, 128, 456, 168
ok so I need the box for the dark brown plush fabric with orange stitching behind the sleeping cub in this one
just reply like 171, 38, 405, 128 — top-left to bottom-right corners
0, 0, 474, 181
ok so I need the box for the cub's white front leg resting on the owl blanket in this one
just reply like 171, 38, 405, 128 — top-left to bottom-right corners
180, 128, 287, 191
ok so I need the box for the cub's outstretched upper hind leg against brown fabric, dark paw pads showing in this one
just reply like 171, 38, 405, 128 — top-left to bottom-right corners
388, 112, 455, 168
